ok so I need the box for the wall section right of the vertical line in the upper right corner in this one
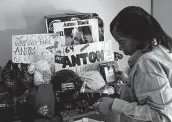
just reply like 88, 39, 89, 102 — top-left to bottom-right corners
153, 0, 172, 36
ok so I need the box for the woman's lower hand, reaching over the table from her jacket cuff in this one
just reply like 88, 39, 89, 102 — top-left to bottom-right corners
93, 97, 114, 115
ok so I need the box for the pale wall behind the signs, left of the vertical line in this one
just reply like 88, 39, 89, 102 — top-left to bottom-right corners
0, 0, 150, 69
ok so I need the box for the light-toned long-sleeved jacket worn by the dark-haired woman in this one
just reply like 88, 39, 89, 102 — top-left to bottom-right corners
112, 46, 172, 122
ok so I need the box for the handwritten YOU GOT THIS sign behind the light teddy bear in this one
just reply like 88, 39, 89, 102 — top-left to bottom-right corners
12, 34, 64, 63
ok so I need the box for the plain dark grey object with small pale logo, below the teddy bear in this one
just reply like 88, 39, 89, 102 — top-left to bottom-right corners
29, 84, 62, 122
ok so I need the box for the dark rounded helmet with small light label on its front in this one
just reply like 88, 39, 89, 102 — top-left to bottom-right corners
52, 69, 82, 111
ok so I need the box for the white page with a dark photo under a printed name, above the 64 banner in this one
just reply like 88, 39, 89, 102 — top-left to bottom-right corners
53, 19, 99, 46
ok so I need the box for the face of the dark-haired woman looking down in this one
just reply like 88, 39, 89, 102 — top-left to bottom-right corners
112, 31, 138, 56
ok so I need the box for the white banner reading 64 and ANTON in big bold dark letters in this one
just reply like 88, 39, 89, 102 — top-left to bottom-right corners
55, 41, 114, 72
